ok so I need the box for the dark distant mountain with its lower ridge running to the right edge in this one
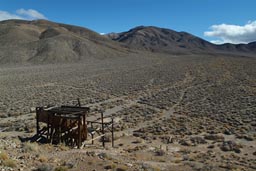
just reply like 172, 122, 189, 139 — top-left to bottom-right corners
107, 26, 256, 53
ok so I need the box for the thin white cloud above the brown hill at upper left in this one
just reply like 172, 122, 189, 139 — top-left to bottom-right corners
0, 8, 47, 21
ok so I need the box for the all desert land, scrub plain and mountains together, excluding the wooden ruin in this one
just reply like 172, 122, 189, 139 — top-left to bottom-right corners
0, 20, 256, 171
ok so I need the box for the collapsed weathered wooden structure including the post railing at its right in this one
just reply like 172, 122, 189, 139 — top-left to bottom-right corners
36, 103, 114, 148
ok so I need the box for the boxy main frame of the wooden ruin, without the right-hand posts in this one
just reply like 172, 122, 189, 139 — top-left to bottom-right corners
36, 106, 90, 148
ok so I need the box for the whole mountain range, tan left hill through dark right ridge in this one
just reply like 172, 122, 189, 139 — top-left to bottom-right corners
0, 20, 256, 64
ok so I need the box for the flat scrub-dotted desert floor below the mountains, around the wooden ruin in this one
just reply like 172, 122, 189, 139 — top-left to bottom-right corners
0, 55, 256, 171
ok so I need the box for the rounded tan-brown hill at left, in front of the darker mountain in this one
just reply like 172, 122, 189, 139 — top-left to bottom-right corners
0, 20, 131, 64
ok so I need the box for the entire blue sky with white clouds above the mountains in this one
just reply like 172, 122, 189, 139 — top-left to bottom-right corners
0, 0, 256, 43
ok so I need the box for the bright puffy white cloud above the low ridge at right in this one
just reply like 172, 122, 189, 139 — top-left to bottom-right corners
204, 21, 256, 44
